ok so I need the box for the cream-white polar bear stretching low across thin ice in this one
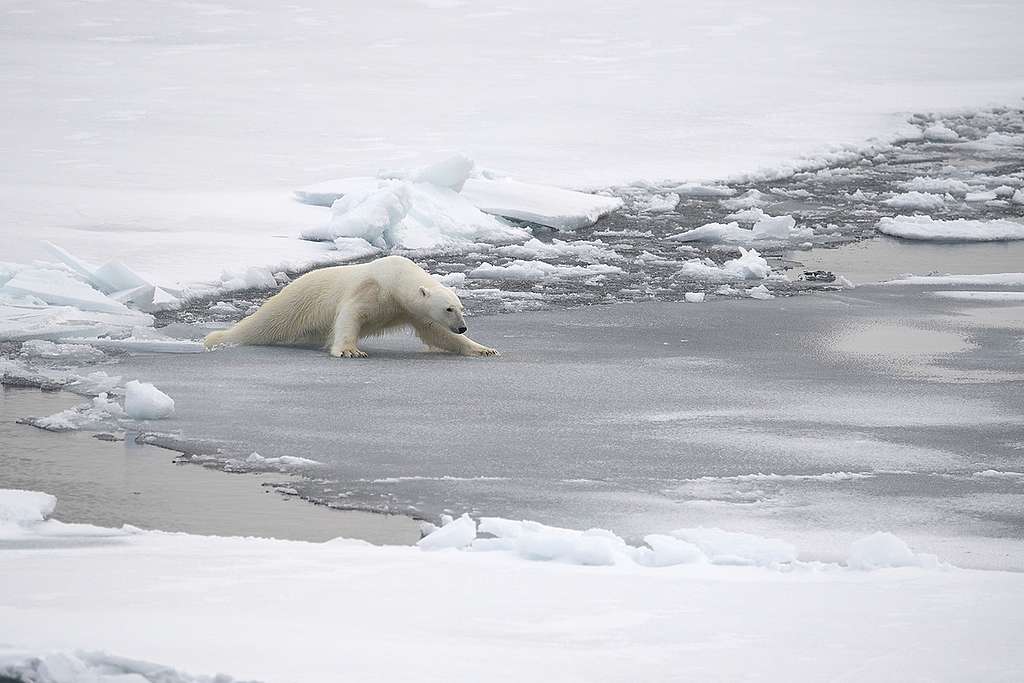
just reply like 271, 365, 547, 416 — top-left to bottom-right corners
204, 256, 498, 358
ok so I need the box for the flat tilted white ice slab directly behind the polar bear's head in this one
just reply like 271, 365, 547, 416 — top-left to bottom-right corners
462, 178, 623, 230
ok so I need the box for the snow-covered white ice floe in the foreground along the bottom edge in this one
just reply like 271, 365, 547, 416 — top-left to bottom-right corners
0, 490, 1024, 683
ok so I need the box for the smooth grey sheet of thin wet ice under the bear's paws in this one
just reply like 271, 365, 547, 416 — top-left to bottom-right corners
122, 287, 1024, 568
